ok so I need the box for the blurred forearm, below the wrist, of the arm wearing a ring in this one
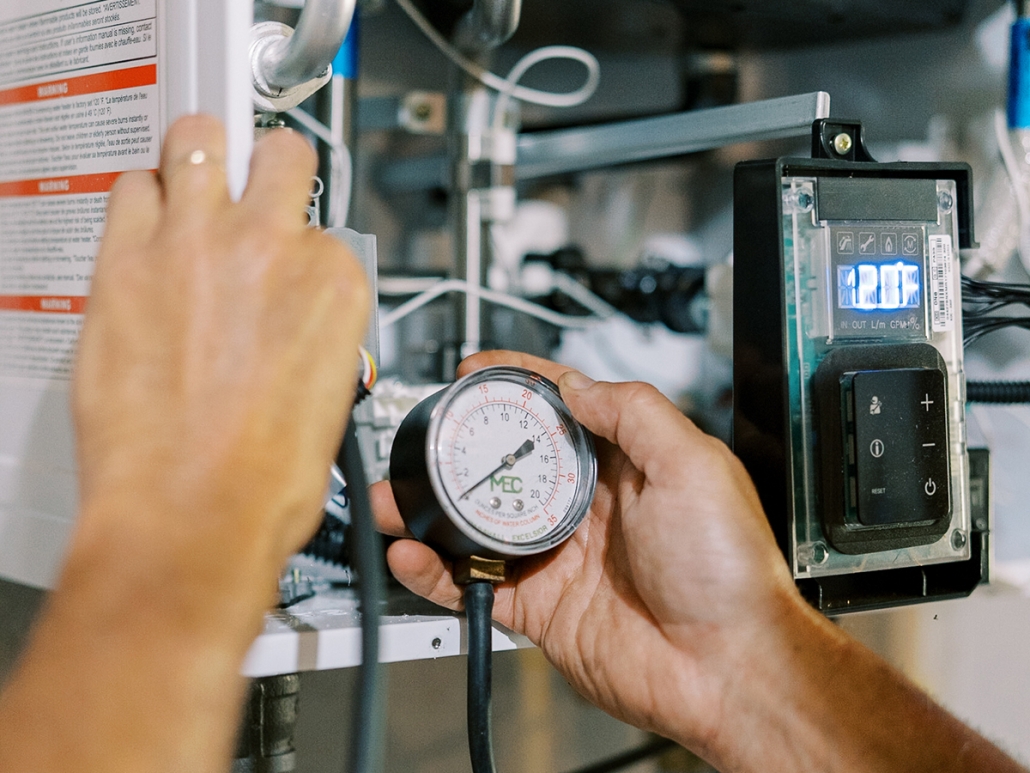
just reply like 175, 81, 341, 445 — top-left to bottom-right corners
0, 502, 275, 773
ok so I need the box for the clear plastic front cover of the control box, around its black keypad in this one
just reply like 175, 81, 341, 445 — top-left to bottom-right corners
783, 177, 969, 577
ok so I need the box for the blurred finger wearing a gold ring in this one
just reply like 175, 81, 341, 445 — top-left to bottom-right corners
160, 115, 230, 221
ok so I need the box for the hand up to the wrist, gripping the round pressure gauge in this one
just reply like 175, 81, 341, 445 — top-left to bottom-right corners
373, 352, 795, 762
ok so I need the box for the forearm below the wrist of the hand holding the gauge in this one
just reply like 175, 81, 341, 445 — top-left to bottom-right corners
719, 589, 1024, 773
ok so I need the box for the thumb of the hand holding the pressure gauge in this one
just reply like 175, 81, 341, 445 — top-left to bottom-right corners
558, 370, 709, 480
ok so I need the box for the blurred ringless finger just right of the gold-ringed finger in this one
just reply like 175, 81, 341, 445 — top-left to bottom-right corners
243, 130, 318, 226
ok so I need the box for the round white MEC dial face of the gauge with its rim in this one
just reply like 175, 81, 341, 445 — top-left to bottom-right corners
427, 367, 596, 556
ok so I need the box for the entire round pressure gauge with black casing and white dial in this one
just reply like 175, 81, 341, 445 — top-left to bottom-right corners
389, 366, 597, 559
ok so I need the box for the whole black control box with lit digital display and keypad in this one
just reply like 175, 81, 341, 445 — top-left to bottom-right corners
733, 122, 988, 611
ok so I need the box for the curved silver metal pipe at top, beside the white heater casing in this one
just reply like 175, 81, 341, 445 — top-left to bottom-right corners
256, 0, 358, 90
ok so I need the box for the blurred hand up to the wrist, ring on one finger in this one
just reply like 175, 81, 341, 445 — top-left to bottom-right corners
74, 116, 369, 563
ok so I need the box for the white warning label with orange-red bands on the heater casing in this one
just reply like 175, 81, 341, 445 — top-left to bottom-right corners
0, 0, 160, 380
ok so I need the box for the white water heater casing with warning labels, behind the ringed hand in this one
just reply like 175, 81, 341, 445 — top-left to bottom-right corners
0, 0, 253, 586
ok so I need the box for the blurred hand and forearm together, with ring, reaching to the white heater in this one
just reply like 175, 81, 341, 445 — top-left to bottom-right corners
0, 116, 369, 773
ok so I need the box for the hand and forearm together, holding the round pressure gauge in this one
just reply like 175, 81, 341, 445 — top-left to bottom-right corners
373, 352, 1022, 773
